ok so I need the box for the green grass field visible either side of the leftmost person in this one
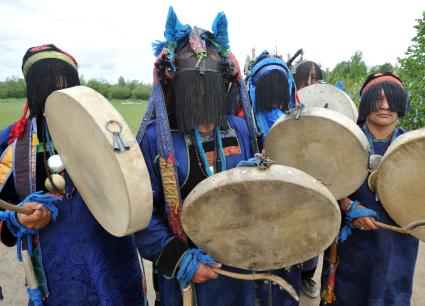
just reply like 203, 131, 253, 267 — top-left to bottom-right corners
0, 99, 147, 133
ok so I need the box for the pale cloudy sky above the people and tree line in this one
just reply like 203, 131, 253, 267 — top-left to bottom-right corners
0, 0, 425, 83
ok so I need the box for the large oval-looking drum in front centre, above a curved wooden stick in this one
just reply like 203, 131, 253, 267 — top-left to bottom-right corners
182, 165, 341, 271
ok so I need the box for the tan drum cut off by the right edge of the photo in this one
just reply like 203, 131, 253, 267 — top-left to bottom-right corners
376, 128, 425, 241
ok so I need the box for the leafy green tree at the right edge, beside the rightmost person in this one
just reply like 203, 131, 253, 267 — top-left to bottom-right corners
398, 12, 425, 129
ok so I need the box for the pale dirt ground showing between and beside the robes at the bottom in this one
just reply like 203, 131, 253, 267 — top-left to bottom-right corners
0, 243, 425, 306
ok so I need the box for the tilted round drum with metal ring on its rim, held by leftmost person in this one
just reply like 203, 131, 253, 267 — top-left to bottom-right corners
45, 86, 152, 236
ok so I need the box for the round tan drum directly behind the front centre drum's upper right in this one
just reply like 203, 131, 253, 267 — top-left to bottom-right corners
264, 107, 368, 199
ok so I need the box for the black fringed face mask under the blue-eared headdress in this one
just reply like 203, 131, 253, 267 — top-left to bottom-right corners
172, 57, 227, 134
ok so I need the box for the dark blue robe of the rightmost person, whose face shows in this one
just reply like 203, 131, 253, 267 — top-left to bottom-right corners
322, 130, 418, 306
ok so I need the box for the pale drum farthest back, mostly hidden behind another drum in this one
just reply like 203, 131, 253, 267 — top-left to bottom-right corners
298, 83, 359, 122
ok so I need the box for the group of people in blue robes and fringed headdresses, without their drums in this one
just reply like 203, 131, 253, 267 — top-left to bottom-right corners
0, 8, 418, 306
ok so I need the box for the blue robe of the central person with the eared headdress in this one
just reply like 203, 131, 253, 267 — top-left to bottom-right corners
135, 116, 301, 306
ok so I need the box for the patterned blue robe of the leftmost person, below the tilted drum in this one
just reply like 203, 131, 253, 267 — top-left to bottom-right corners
0, 126, 147, 306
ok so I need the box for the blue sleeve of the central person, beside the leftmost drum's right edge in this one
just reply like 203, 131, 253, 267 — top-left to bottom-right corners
134, 123, 174, 261
